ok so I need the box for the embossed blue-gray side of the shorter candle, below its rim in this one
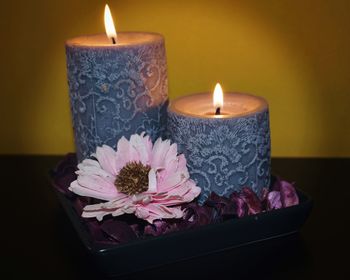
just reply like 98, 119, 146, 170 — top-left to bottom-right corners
168, 110, 270, 203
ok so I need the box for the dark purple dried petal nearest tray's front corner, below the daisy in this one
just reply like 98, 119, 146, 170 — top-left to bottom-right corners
100, 219, 137, 243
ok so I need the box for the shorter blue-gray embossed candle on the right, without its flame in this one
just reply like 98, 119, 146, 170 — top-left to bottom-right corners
168, 83, 270, 203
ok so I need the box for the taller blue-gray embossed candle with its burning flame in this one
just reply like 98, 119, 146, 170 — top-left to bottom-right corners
66, 5, 168, 161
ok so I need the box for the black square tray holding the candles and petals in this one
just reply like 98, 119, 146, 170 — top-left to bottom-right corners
57, 186, 313, 276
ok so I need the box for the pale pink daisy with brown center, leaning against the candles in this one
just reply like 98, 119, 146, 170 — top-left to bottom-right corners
69, 133, 201, 223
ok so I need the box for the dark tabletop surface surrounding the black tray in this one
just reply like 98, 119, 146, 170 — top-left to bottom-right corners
0, 156, 350, 280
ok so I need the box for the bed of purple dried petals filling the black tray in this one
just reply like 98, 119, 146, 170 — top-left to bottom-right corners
52, 154, 299, 245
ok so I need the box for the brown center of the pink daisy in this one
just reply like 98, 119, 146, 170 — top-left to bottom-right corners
114, 162, 151, 195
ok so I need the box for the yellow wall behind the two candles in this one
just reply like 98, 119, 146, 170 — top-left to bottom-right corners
0, 0, 350, 157
